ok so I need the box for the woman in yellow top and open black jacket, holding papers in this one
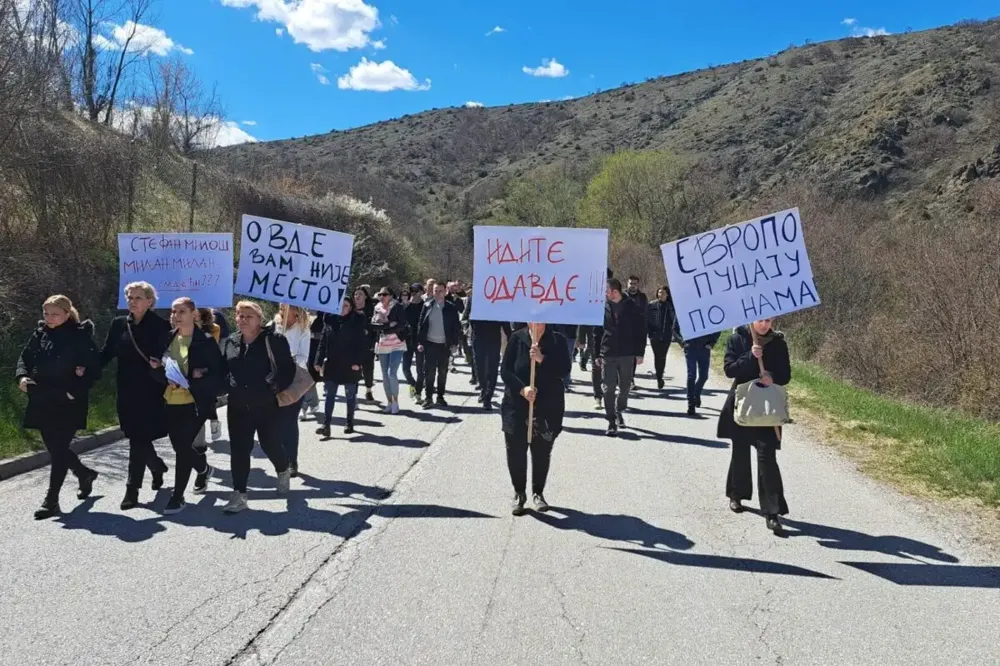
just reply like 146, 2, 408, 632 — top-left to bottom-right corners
160, 298, 223, 515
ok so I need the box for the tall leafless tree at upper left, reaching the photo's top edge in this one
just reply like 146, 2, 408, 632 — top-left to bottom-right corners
63, 0, 153, 125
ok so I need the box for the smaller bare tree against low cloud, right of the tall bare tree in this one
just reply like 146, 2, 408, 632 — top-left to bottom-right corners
146, 58, 223, 155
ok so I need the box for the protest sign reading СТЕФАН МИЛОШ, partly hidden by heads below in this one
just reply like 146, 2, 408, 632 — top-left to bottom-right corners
118, 234, 233, 310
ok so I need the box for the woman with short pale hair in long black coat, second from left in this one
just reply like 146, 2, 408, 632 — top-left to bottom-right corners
101, 282, 170, 511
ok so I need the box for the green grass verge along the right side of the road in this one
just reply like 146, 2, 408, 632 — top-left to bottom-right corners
713, 335, 1000, 506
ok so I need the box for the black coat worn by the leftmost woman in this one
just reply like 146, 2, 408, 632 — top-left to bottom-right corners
15, 321, 101, 432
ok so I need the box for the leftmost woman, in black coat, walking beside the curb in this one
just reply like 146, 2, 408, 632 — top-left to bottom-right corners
15, 296, 101, 520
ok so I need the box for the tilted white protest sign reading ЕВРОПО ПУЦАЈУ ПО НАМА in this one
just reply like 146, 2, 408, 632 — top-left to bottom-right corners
660, 208, 819, 339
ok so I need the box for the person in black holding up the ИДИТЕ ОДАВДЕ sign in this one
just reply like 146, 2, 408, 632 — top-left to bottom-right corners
500, 324, 573, 516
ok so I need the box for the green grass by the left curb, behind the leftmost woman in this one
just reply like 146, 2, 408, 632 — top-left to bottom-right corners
0, 372, 118, 459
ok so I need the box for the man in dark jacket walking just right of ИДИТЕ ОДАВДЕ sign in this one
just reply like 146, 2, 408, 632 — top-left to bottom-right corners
598, 278, 646, 437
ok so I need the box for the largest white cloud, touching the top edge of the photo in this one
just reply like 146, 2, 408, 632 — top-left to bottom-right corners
222, 0, 381, 52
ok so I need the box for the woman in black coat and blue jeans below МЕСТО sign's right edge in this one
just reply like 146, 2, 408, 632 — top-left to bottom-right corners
314, 298, 372, 437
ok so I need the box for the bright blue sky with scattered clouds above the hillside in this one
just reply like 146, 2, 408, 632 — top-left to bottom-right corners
156, 0, 1000, 140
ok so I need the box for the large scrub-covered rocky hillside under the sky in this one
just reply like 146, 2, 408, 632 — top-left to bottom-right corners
208, 20, 1000, 249
